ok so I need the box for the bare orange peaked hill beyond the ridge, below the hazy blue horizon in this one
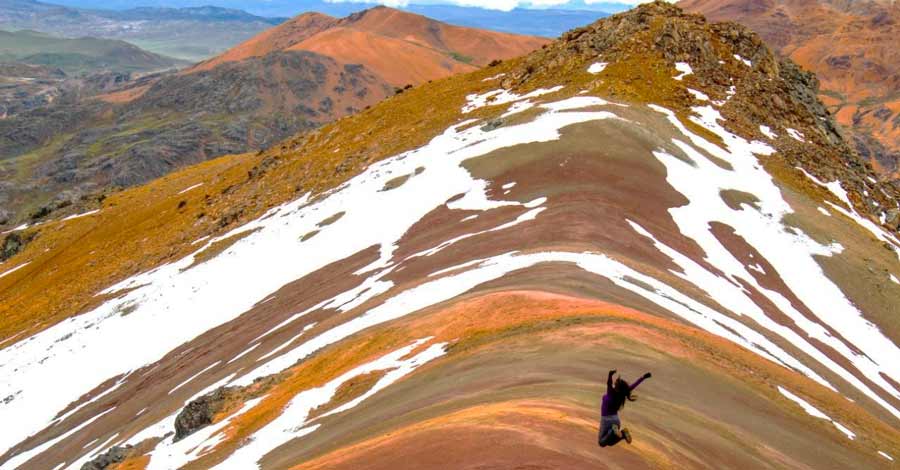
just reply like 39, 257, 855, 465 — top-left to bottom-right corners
190, 7, 549, 86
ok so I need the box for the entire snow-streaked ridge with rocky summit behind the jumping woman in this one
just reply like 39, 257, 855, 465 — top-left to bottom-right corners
0, 3, 900, 469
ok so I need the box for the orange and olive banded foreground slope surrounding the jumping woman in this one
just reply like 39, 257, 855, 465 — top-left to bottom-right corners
284, 290, 891, 470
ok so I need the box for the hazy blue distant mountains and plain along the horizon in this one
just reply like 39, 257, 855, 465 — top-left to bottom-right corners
0, 0, 625, 54
